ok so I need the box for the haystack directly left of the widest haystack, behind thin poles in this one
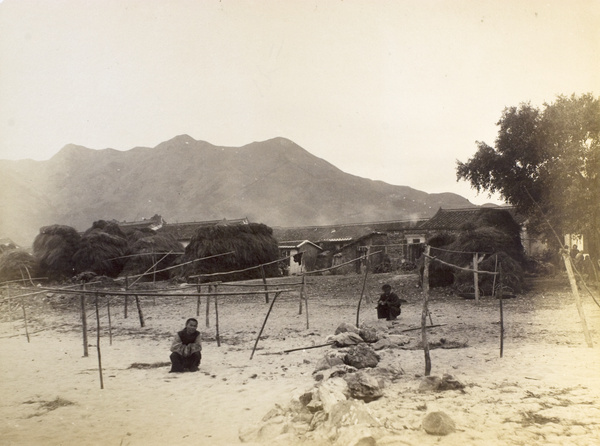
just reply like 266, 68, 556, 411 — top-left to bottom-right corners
123, 229, 183, 280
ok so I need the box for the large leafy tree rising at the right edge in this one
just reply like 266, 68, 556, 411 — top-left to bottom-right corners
456, 94, 600, 256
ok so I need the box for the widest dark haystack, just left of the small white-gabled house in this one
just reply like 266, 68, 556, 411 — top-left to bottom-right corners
174, 223, 279, 281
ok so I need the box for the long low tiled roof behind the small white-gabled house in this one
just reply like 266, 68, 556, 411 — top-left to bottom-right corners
273, 219, 425, 243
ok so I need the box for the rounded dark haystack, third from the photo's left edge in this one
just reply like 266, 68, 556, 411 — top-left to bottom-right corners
73, 220, 129, 277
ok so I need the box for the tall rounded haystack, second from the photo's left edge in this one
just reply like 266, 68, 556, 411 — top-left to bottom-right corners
33, 225, 81, 280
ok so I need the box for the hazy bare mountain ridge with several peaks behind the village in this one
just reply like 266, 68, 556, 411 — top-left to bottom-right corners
0, 135, 473, 246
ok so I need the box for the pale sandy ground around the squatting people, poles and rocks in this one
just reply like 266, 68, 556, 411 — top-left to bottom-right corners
0, 274, 600, 446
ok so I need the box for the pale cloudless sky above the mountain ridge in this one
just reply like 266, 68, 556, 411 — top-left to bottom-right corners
0, 0, 600, 204
